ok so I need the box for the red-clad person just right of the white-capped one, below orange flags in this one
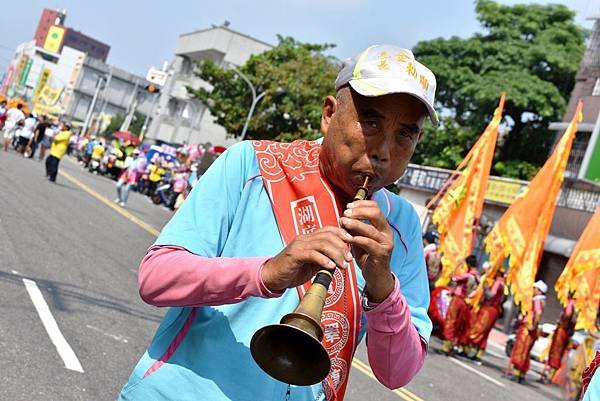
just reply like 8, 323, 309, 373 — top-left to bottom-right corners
544, 296, 576, 382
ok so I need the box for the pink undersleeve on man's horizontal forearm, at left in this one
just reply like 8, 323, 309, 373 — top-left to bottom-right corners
138, 246, 283, 306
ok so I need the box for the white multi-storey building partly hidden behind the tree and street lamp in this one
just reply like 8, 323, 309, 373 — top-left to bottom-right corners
146, 26, 272, 146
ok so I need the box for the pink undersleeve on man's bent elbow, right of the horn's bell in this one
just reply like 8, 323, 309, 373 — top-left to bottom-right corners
366, 277, 427, 389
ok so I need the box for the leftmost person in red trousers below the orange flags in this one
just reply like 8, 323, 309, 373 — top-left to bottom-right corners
442, 255, 478, 355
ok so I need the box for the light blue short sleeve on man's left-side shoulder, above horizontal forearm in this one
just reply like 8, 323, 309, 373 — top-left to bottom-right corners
155, 141, 256, 257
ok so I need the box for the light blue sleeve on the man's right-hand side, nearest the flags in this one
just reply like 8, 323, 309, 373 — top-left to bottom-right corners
390, 194, 432, 342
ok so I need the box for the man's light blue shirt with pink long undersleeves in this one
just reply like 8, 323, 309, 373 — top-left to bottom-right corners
119, 142, 431, 401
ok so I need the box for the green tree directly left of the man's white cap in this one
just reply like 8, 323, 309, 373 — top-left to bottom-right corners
187, 36, 338, 141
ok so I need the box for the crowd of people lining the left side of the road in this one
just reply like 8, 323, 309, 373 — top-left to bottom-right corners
0, 101, 209, 210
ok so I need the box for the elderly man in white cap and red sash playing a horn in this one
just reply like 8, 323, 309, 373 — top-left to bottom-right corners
120, 45, 437, 401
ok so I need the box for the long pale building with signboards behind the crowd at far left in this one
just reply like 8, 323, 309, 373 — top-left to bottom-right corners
2, 41, 151, 129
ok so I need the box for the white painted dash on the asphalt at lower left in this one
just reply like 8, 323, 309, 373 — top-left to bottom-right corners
23, 278, 83, 373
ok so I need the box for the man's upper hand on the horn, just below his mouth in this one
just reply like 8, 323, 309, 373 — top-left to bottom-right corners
341, 200, 394, 303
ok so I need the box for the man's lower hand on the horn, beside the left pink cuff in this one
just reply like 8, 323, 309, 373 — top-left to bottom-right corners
262, 226, 352, 291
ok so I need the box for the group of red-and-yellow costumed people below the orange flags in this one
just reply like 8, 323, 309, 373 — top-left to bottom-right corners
423, 232, 600, 400
